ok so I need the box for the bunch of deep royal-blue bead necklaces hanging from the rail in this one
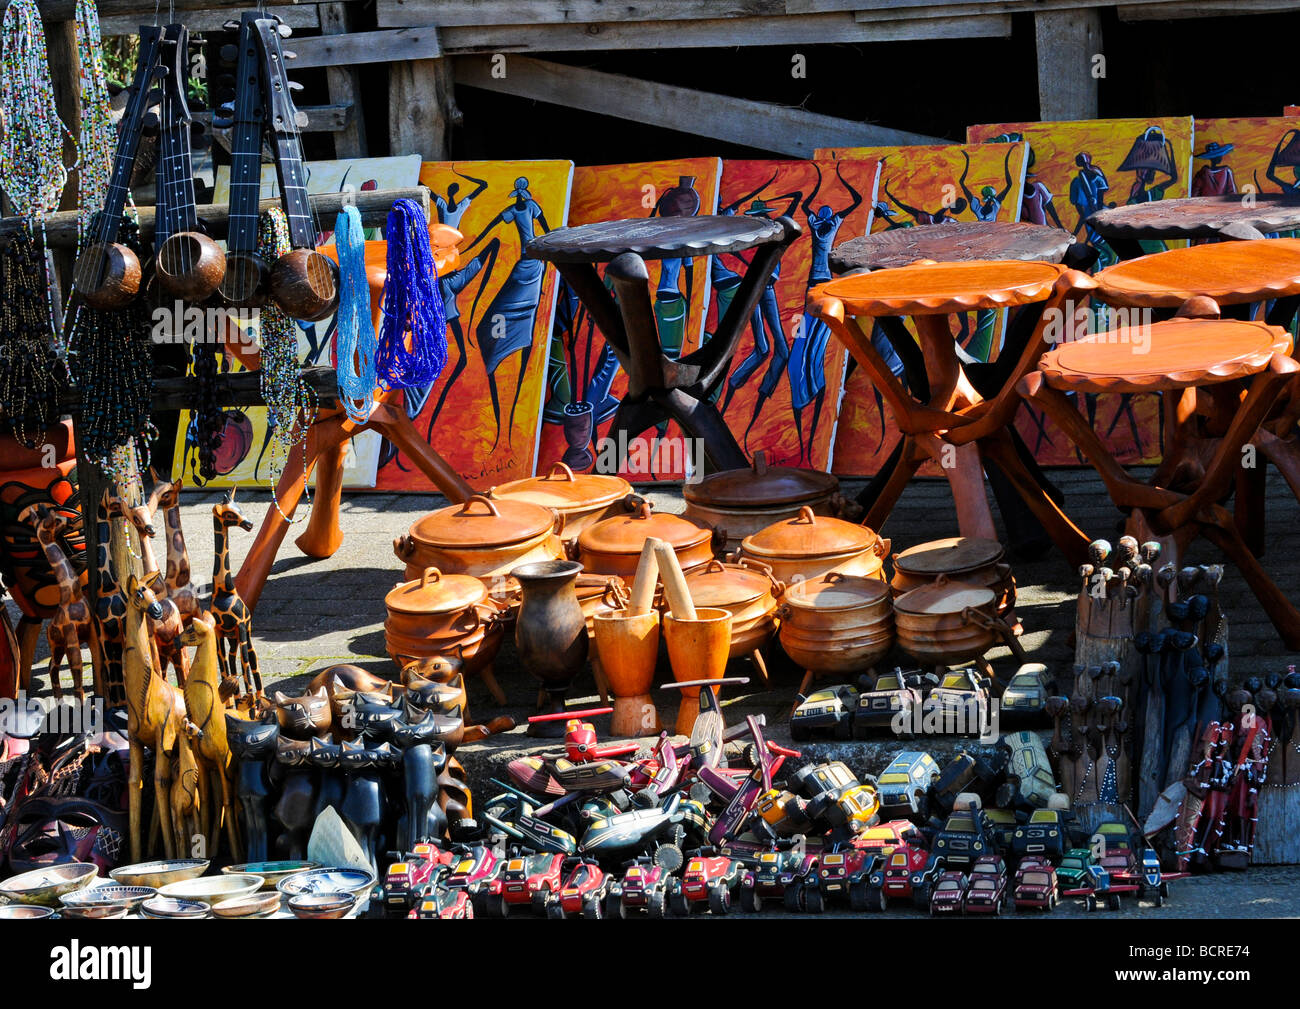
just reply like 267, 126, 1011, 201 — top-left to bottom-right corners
374, 200, 447, 389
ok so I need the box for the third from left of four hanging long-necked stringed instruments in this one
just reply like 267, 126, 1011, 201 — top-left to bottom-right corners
221, 10, 270, 307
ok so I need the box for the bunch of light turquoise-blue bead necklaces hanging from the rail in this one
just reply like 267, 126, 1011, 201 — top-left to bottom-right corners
334, 207, 378, 424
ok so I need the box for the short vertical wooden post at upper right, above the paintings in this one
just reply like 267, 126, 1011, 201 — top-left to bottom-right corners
1034, 8, 1105, 122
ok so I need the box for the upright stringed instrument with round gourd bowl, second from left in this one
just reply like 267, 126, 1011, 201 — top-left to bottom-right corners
153, 25, 226, 302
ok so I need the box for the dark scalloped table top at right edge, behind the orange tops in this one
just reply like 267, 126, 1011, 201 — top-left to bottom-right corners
1088, 192, 1300, 259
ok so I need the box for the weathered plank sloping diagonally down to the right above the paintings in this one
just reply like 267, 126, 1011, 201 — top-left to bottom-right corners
455, 56, 943, 157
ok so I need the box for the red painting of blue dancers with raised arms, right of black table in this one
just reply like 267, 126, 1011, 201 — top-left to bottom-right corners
706, 159, 880, 469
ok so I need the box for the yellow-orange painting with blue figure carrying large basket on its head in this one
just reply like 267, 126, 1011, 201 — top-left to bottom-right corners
966, 116, 1193, 465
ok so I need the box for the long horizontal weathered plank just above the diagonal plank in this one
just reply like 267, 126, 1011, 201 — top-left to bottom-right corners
378, 11, 1011, 55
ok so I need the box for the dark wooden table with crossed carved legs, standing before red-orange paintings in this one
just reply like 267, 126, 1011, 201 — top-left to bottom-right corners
527, 216, 800, 469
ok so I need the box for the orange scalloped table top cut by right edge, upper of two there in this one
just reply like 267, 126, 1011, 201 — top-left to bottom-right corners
1093, 238, 1300, 308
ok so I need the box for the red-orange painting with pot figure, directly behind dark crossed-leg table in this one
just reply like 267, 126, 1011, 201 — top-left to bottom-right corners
538, 157, 722, 481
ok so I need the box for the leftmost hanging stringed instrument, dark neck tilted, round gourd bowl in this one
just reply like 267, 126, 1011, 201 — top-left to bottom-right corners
73, 25, 163, 309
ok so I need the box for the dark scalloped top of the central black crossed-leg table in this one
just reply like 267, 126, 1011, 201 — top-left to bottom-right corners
528, 215, 783, 263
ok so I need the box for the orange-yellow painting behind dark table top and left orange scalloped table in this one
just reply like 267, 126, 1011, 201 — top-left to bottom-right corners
816, 142, 1027, 476
